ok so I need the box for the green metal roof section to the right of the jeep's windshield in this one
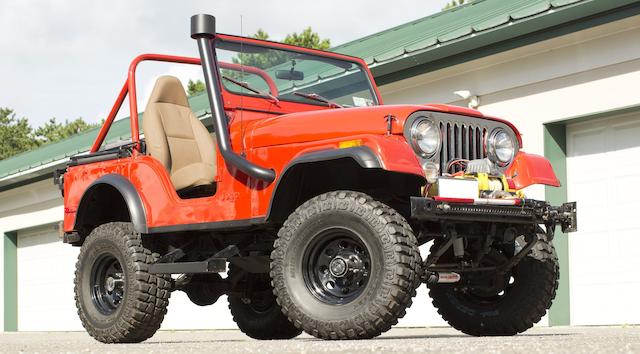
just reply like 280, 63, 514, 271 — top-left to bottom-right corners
331, 0, 639, 84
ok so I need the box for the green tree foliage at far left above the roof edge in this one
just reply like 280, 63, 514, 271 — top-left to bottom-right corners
0, 108, 97, 160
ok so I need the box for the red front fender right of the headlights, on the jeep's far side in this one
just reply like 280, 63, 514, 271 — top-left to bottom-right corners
506, 151, 560, 189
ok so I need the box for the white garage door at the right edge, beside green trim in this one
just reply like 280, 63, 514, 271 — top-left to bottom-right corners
567, 113, 640, 325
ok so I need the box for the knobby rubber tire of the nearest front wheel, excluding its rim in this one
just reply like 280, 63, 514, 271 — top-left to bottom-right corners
271, 191, 421, 339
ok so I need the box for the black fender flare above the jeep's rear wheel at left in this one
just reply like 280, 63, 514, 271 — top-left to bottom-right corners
74, 173, 149, 233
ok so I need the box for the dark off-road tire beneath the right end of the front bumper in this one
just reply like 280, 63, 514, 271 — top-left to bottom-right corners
429, 235, 560, 336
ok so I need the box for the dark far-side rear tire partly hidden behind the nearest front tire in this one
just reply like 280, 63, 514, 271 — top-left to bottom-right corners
228, 266, 302, 339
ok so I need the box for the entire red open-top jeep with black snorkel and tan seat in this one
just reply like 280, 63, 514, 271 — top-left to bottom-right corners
55, 15, 576, 342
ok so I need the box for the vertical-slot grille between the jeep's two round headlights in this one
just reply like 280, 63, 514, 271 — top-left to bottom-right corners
440, 122, 487, 173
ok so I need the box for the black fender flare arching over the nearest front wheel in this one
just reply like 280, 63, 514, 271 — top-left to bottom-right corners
266, 146, 383, 221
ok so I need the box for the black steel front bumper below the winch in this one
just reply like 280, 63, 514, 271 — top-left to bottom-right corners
411, 197, 578, 232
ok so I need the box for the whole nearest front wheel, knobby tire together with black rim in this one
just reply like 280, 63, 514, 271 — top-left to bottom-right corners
271, 191, 421, 339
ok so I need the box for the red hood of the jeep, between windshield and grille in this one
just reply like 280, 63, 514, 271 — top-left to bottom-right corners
245, 105, 492, 148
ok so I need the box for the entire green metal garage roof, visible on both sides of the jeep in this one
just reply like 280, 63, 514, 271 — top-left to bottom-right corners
0, 0, 640, 190
